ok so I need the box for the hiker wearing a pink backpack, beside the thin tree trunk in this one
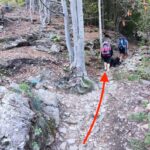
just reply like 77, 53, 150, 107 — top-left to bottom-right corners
101, 41, 113, 72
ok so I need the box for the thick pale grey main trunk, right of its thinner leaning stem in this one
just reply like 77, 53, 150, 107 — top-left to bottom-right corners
70, 0, 87, 76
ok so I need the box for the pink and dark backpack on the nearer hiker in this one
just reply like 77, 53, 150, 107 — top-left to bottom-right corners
101, 42, 111, 57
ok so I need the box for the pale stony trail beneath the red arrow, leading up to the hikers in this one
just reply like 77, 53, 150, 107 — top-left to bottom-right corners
52, 53, 150, 150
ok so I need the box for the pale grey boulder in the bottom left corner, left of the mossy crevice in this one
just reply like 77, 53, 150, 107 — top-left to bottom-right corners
0, 92, 34, 150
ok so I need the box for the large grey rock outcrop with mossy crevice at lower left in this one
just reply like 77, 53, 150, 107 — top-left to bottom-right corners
0, 86, 59, 150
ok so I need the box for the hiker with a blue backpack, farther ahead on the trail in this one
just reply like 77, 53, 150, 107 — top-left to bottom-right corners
118, 37, 128, 62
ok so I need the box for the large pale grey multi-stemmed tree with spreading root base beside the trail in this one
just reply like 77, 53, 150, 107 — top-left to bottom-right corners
61, 0, 93, 92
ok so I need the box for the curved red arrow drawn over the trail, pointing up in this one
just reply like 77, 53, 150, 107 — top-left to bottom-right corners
83, 73, 109, 144
